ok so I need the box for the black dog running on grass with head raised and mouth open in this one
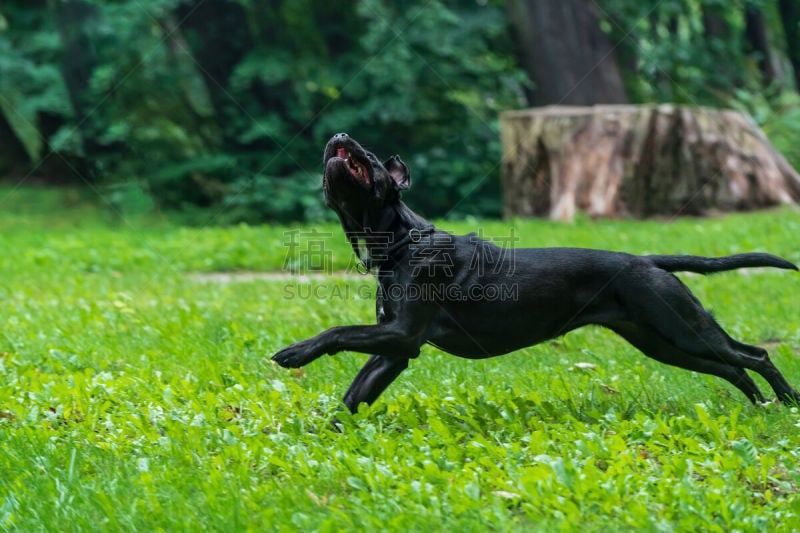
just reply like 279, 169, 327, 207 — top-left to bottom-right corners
272, 133, 800, 412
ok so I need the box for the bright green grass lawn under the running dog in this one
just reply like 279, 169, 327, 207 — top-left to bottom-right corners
0, 189, 800, 532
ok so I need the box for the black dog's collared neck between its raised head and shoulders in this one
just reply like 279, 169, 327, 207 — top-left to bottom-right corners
342, 201, 434, 270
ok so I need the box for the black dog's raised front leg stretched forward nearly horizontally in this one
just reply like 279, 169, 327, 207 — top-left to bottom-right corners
272, 322, 424, 368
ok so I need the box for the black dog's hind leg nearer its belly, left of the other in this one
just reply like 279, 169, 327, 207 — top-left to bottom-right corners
608, 322, 766, 403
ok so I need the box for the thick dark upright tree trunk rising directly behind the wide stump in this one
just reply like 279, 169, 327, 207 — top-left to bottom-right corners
508, 0, 628, 105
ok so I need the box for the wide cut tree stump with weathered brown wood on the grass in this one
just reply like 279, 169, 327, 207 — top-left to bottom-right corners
500, 105, 800, 221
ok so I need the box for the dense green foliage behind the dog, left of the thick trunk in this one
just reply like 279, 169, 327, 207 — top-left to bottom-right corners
0, 0, 524, 222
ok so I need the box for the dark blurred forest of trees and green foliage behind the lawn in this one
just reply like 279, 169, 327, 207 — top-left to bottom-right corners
0, 0, 800, 222
